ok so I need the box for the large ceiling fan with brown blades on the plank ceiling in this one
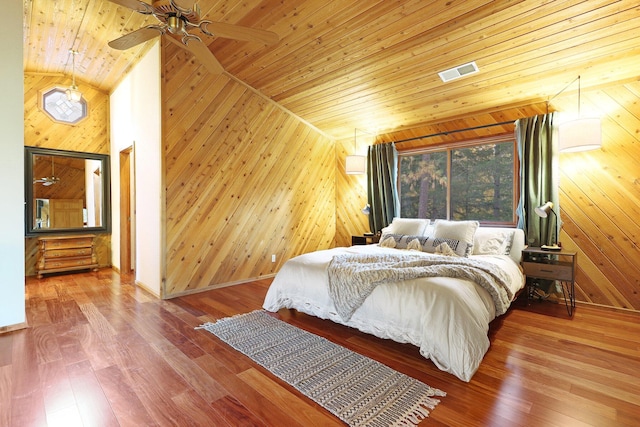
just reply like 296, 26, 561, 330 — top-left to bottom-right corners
109, 0, 279, 74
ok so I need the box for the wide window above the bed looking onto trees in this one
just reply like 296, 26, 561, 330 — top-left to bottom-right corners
398, 135, 517, 225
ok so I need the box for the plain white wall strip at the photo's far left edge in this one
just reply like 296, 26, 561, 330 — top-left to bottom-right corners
0, 0, 25, 329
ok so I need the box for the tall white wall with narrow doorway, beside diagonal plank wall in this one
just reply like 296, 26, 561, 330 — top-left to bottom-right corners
110, 42, 164, 296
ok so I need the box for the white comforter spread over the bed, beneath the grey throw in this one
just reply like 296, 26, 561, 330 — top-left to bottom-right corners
263, 245, 524, 381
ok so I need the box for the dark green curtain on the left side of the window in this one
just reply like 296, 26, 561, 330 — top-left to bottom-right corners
367, 143, 400, 233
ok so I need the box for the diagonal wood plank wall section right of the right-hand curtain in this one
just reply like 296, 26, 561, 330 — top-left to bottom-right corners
558, 81, 640, 310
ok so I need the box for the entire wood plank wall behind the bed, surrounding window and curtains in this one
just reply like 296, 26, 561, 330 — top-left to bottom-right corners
336, 81, 640, 311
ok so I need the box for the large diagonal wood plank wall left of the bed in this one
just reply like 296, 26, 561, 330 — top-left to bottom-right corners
162, 42, 336, 297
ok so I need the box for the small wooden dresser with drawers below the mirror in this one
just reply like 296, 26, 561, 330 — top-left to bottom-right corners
36, 234, 98, 279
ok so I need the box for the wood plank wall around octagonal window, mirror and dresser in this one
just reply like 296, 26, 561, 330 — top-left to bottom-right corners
24, 73, 111, 276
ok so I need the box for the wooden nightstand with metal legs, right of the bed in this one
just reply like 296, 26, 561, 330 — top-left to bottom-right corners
522, 247, 578, 316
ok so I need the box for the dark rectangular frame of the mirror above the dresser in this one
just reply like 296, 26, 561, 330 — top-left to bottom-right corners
24, 146, 111, 237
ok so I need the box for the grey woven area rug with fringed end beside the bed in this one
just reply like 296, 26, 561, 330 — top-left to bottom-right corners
200, 310, 446, 427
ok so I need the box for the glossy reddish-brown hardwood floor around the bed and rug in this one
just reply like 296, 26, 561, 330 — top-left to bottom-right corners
0, 269, 640, 427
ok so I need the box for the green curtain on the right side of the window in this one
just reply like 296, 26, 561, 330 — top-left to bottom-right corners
516, 113, 561, 246
